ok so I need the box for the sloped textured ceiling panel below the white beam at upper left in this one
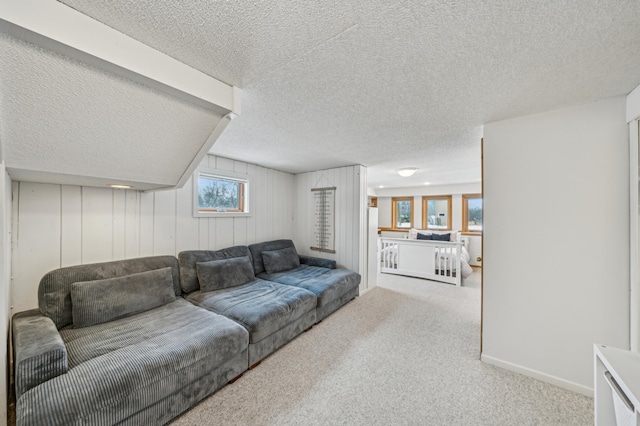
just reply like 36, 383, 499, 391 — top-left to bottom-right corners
0, 31, 220, 189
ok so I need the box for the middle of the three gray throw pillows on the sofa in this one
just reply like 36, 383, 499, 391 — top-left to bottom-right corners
196, 256, 256, 291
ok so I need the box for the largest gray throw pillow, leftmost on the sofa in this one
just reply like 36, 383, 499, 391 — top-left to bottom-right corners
71, 267, 176, 328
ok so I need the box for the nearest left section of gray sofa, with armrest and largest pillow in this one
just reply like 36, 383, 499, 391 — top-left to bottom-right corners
12, 256, 249, 426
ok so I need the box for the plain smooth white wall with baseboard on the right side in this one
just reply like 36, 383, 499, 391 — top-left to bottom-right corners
482, 98, 629, 394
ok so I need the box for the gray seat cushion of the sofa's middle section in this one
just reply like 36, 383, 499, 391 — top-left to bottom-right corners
186, 279, 316, 343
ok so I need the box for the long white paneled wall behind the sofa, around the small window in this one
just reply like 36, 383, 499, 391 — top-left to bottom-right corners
12, 155, 295, 312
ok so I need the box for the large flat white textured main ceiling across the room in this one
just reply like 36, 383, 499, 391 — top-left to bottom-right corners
48, 0, 640, 186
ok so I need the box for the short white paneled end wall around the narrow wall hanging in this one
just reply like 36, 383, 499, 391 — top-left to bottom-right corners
294, 166, 367, 290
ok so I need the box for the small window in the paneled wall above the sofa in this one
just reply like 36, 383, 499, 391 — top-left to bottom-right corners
194, 170, 249, 217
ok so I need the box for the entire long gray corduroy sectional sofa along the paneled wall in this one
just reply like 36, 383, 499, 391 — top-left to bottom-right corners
12, 240, 360, 426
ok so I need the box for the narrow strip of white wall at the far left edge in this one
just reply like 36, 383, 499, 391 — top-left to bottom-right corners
0, 162, 11, 425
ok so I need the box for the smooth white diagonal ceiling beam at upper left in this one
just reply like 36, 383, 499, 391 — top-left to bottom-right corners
0, 0, 240, 114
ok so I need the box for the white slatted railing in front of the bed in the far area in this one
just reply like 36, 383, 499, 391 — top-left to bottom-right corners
378, 238, 462, 286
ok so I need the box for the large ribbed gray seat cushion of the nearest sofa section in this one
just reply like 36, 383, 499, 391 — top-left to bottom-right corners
16, 299, 249, 425
